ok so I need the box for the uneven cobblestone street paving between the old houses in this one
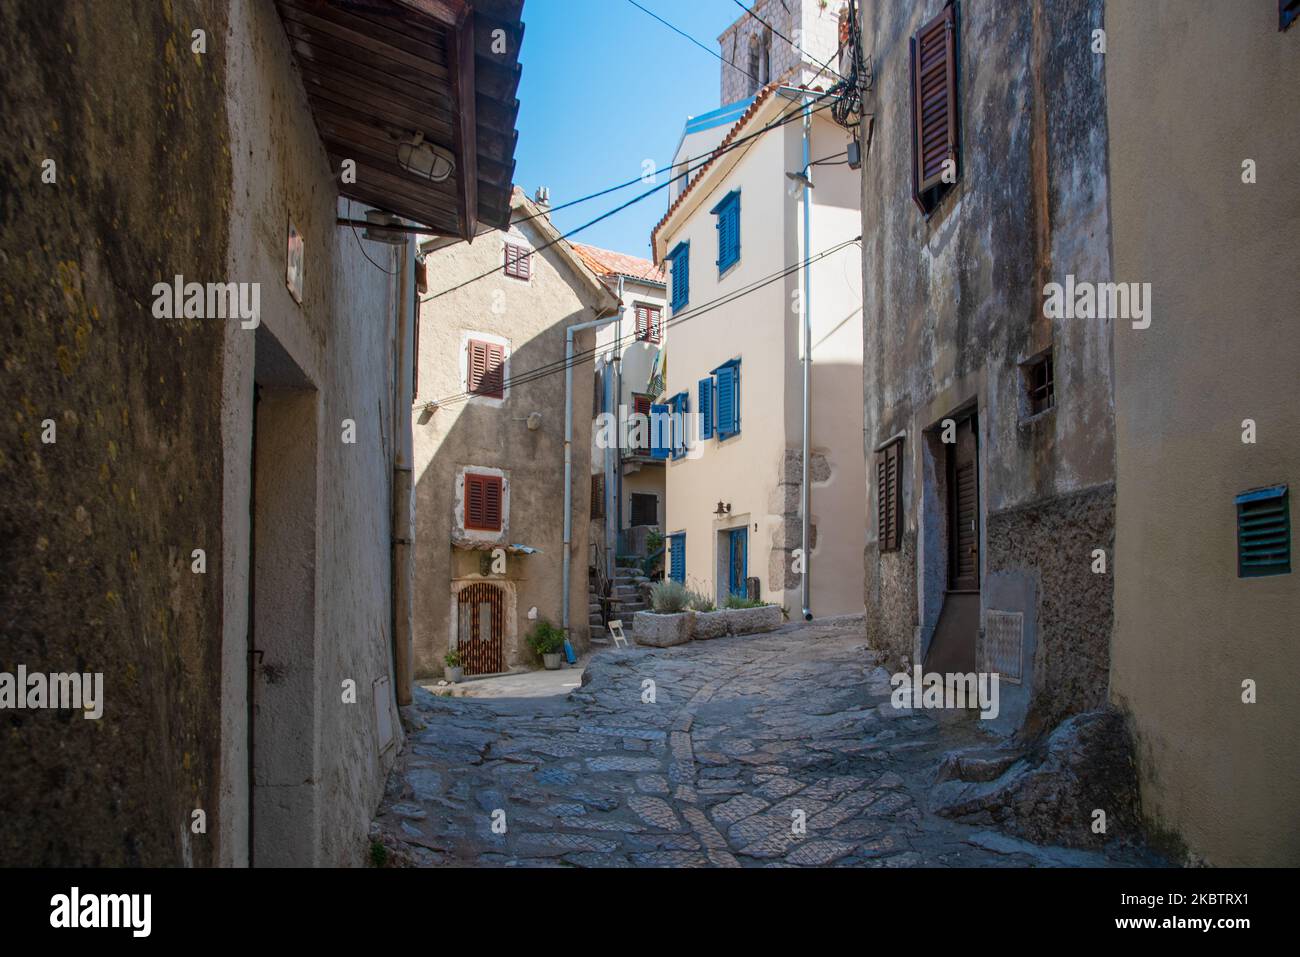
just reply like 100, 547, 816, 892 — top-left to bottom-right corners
372, 619, 1159, 867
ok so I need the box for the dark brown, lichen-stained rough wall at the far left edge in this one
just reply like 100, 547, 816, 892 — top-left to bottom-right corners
0, 0, 231, 866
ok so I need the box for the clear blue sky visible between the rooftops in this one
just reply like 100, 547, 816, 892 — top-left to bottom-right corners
515, 0, 748, 259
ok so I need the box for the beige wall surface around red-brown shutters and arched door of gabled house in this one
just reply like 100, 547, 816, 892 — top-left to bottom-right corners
415, 208, 616, 676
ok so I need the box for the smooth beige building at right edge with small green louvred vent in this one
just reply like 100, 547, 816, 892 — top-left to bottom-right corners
1105, 0, 1300, 867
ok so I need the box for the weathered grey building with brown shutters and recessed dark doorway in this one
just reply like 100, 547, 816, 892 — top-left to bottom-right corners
859, 0, 1115, 732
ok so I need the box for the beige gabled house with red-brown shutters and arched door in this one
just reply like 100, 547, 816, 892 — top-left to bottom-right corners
415, 189, 618, 676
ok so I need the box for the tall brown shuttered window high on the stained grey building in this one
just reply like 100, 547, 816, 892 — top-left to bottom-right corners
911, 3, 958, 215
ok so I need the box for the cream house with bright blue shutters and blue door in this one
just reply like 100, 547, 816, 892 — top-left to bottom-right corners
651, 83, 865, 618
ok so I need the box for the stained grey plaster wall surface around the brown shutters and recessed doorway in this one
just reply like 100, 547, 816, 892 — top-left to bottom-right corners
862, 0, 1114, 733
